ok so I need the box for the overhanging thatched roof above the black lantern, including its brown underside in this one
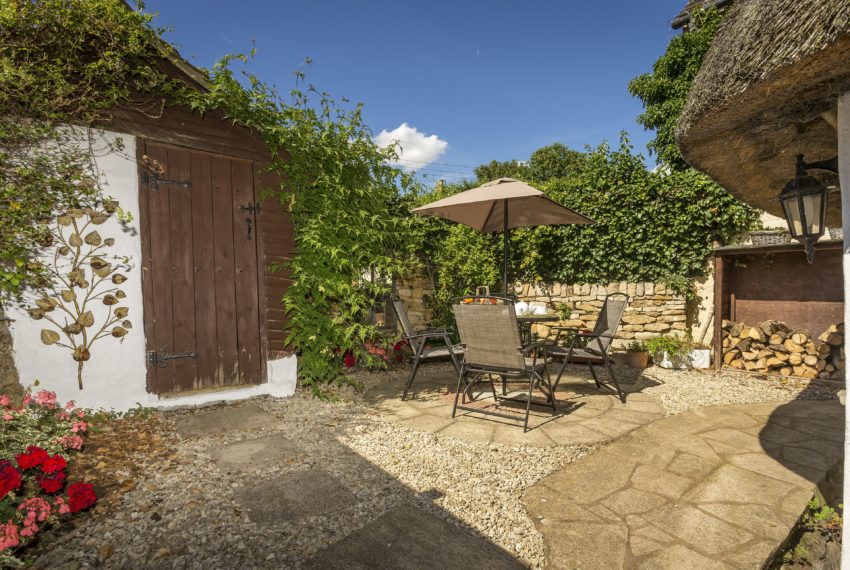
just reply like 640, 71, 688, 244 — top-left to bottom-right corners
677, 0, 850, 222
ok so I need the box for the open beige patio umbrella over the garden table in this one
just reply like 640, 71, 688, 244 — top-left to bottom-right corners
411, 178, 593, 295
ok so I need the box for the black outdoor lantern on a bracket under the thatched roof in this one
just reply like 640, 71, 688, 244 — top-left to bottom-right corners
779, 154, 838, 263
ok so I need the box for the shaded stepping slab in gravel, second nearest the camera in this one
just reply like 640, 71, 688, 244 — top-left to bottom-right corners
236, 469, 357, 526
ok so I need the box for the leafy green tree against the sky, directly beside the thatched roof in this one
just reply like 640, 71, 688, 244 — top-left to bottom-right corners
629, 8, 723, 170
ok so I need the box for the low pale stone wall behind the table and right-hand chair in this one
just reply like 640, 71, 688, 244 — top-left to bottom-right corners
516, 282, 690, 348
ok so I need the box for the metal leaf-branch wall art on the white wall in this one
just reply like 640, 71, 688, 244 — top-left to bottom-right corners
28, 206, 133, 390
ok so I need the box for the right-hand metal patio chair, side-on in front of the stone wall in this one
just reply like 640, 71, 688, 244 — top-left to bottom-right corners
547, 293, 629, 403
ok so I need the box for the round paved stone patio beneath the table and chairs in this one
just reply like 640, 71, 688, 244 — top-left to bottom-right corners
365, 367, 664, 446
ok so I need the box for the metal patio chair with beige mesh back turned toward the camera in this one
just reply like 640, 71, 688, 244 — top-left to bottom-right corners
452, 297, 557, 432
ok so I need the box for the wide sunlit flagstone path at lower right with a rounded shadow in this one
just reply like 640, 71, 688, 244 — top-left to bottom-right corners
524, 400, 844, 570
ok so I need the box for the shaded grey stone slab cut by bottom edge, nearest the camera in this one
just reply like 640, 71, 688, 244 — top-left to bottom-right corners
307, 505, 524, 570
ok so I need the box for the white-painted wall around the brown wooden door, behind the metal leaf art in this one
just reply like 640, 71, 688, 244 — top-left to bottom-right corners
8, 130, 296, 410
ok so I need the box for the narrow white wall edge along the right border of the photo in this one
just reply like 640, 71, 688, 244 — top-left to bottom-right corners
838, 92, 850, 570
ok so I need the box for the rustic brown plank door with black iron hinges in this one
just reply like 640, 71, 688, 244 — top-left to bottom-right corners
138, 140, 265, 393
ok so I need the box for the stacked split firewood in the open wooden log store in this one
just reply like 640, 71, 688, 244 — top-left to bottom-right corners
723, 320, 844, 379
